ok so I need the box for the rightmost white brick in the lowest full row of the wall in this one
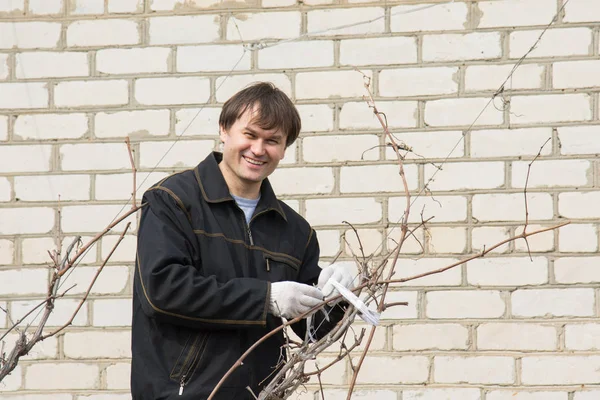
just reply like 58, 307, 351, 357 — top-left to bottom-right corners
521, 355, 600, 385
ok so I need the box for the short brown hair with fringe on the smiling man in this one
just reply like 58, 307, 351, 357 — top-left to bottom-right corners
219, 82, 301, 147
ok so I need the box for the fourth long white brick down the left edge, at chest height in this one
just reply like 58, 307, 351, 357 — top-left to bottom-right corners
0, 207, 54, 235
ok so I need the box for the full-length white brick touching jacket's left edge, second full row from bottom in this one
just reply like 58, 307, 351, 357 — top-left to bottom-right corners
63, 330, 131, 359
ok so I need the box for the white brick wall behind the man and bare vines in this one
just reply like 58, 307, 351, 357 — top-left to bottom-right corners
0, 0, 600, 400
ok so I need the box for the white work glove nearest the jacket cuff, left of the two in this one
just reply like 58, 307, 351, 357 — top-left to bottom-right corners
269, 281, 323, 319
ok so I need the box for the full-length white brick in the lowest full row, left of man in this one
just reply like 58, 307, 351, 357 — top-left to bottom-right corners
25, 363, 100, 390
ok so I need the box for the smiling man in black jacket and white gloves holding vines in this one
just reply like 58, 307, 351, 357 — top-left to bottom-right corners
131, 83, 352, 400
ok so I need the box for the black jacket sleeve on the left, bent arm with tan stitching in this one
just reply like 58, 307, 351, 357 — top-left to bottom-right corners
134, 189, 270, 329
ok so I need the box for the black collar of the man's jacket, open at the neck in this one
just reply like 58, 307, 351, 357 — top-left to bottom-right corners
194, 151, 287, 222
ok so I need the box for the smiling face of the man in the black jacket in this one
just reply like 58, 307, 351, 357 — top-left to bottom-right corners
219, 107, 286, 198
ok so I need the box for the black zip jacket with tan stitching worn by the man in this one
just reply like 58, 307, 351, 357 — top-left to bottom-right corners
131, 153, 340, 400
